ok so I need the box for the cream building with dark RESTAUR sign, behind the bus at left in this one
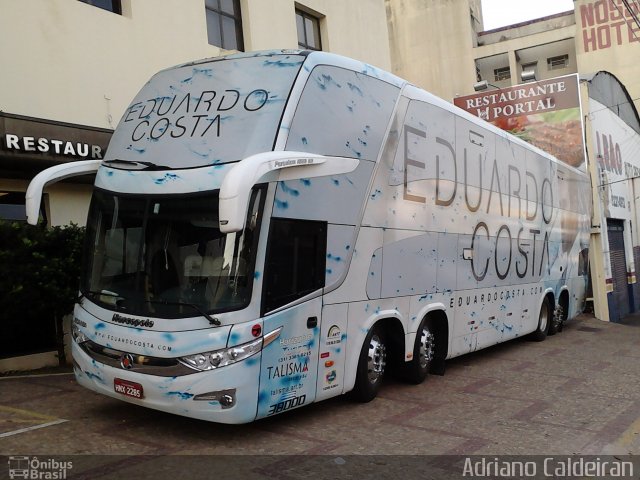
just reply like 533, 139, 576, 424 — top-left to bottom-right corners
0, 0, 391, 371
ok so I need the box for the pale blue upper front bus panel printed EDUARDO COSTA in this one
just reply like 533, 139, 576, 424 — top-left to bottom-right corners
105, 57, 302, 168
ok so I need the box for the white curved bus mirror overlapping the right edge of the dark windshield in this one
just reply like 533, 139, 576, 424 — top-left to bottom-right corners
219, 151, 359, 233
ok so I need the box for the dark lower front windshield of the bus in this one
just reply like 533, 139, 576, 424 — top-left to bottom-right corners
81, 187, 264, 318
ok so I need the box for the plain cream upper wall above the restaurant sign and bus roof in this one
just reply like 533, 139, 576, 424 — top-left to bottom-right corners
0, 0, 390, 128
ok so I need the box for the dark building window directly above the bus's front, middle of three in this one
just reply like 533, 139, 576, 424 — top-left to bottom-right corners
204, 0, 244, 51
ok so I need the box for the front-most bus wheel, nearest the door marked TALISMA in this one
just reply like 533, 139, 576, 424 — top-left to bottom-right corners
352, 325, 387, 403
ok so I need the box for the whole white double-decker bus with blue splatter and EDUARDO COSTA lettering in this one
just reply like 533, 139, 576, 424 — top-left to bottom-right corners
27, 51, 591, 423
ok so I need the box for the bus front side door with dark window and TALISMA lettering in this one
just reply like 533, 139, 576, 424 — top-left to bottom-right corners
257, 218, 327, 418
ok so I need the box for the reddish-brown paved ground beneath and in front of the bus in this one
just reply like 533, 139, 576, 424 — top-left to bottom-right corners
0, 315, 640, 478
